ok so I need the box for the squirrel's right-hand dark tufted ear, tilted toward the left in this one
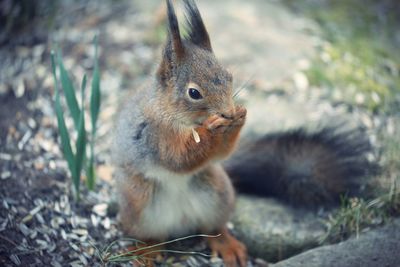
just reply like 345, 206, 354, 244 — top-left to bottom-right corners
184, 0, 212, 51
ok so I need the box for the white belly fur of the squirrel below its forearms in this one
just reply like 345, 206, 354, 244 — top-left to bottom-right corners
140, 169, 220, 238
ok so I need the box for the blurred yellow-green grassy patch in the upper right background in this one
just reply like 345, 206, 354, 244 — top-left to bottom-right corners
285, 0, 400, 112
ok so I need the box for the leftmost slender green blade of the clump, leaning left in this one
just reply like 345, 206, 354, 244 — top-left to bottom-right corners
51, 51, 79, 198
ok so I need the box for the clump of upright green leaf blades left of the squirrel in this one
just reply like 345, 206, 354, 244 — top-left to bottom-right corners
51, 37, 101, 200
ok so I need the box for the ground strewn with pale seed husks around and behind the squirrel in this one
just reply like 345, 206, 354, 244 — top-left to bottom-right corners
0, 0, 400, 266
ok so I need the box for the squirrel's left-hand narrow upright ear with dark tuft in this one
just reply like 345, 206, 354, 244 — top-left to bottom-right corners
167, 0, 185, 60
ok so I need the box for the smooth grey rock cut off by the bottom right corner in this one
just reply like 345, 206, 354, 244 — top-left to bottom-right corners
271, 219, 400, 267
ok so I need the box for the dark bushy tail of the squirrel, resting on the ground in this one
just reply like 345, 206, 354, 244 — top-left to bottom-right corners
224, 126, 378, 206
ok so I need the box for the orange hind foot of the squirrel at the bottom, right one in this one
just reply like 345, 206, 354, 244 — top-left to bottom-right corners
207, 230, 247, 267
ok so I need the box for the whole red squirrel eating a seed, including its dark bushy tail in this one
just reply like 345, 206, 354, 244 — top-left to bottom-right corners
112, 0, 376, 267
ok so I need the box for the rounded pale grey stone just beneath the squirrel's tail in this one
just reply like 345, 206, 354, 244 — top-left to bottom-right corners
232, 196, 325, 262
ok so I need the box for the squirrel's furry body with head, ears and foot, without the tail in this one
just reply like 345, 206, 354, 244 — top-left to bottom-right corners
113, 0, 246, 266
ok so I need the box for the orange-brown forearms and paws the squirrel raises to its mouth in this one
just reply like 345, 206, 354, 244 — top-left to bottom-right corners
151, 104, 246, 173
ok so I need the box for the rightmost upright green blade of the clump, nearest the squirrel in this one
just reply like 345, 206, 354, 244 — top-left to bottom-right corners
90, 36, 101, 136
